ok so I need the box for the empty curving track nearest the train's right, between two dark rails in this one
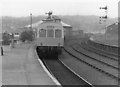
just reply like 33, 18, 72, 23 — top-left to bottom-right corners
63, 48, 118, 80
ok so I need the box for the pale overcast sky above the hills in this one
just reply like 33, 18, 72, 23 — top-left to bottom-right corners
0, 0, 120, 18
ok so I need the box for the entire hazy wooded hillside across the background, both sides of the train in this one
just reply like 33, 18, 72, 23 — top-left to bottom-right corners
2, 15, 116, 32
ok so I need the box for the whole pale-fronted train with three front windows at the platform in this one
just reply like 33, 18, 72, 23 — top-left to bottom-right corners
35, 12, 71, 56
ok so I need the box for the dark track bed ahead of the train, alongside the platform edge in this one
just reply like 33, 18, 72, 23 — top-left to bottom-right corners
36, 48, 94, 87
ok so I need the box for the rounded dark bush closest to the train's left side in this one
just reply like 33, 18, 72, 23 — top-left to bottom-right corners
20, 30, 34, 42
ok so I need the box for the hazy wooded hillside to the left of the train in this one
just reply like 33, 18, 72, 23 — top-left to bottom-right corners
2, 16, 43, 32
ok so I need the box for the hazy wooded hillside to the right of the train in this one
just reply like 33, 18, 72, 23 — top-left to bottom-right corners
62, 15, 116, 33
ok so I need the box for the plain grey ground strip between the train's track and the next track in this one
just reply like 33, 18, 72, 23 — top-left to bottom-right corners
59, 51, 118, 85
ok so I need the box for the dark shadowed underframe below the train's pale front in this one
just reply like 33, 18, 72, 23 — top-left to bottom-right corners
37, 46, 63, 59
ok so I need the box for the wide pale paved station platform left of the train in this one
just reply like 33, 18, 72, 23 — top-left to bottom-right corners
2, 44, 56, 85
